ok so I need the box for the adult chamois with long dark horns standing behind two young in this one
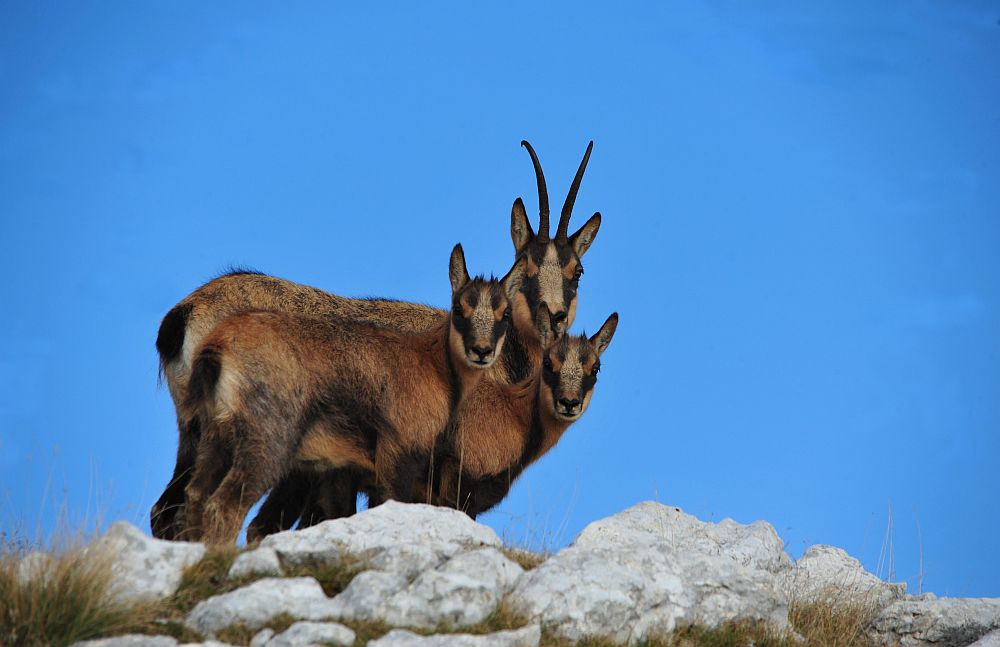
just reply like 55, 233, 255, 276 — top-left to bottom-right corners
150, 142, 601, 539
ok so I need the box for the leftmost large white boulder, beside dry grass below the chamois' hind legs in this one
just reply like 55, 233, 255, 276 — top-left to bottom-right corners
87, 521, 205, 603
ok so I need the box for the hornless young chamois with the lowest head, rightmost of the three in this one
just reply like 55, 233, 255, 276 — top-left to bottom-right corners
434, 303, 618, 519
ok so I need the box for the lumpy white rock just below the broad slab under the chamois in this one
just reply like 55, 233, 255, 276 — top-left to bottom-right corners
334, 548, 523, 629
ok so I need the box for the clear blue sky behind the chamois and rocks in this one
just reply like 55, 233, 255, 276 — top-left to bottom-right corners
0, 2, 1000, 596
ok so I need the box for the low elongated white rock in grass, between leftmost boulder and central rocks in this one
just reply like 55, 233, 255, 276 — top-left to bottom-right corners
184, 577, 342, 638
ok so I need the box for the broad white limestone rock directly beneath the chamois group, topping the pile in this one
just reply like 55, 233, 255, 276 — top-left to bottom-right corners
261, 501, 501, 579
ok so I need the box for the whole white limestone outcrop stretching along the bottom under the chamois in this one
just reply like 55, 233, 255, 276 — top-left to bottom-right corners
52, 502, 1000, 647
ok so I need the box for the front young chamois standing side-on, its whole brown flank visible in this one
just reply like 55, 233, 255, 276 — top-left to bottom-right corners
185, 245, 524, 543
